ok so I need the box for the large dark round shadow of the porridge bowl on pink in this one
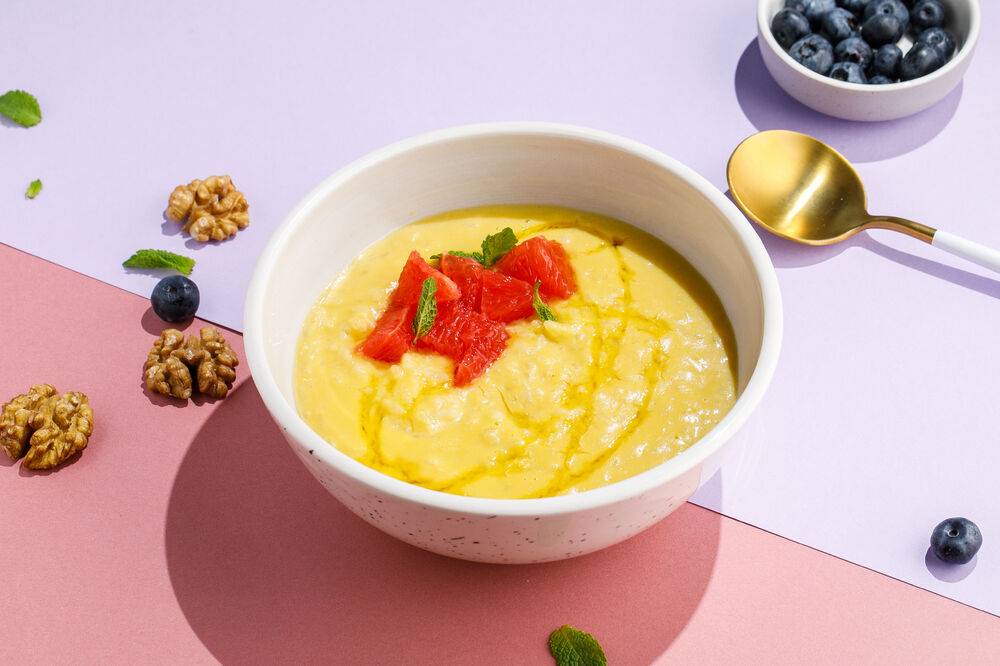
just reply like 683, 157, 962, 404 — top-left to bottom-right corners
165, 382, 721, 665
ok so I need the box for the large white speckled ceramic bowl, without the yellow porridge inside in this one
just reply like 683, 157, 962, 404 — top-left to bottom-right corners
244, 123, 781, 563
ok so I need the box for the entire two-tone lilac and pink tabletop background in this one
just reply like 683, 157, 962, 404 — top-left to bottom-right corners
0, 0, 1000, 664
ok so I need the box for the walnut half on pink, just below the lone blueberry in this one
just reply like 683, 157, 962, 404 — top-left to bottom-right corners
144, 326, 240, 400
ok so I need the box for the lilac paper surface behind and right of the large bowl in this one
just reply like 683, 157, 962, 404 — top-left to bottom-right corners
0, 0, 1000, 614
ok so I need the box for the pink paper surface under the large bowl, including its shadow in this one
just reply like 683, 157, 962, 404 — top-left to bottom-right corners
0, 245, 1000, 666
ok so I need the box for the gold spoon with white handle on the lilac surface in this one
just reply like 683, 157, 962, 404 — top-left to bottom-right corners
726, 130, 1000, 271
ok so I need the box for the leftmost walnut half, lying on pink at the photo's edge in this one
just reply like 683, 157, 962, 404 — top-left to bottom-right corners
0, 384, 94, 469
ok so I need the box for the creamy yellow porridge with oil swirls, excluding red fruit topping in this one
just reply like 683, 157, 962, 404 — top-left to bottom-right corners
294, 206, 735, 498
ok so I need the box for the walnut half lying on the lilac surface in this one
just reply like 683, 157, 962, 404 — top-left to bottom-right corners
165, 176, 250, 242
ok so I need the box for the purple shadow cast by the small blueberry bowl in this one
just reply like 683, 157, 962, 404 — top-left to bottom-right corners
735, 38, 962, 162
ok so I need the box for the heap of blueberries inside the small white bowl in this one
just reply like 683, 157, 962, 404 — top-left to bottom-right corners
771, 0, 955, 84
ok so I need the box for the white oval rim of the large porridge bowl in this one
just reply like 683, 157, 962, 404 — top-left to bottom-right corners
243, 122, 782, 517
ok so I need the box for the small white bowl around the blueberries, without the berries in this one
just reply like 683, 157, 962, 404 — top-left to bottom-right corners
757, 0, 979, 120
